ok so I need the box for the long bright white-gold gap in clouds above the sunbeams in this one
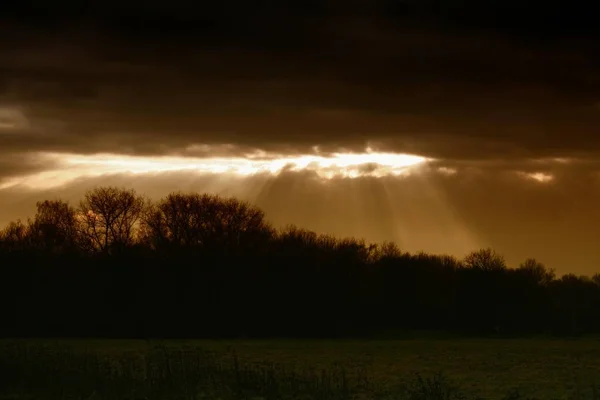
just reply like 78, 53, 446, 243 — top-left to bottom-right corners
0, 148, 430, 189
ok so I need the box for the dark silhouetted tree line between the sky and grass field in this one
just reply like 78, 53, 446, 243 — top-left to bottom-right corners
0, 187, 600, 338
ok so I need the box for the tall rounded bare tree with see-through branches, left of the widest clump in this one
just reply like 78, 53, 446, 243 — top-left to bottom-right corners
78, 187, 146, 252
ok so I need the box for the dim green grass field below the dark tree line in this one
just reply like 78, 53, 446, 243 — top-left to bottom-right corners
0, 339, 600, 399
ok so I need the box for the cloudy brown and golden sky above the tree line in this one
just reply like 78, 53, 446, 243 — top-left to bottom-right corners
0, 0, 600, 274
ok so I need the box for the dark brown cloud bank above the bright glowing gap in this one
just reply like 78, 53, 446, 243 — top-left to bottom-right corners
0, 2, 600, 158
